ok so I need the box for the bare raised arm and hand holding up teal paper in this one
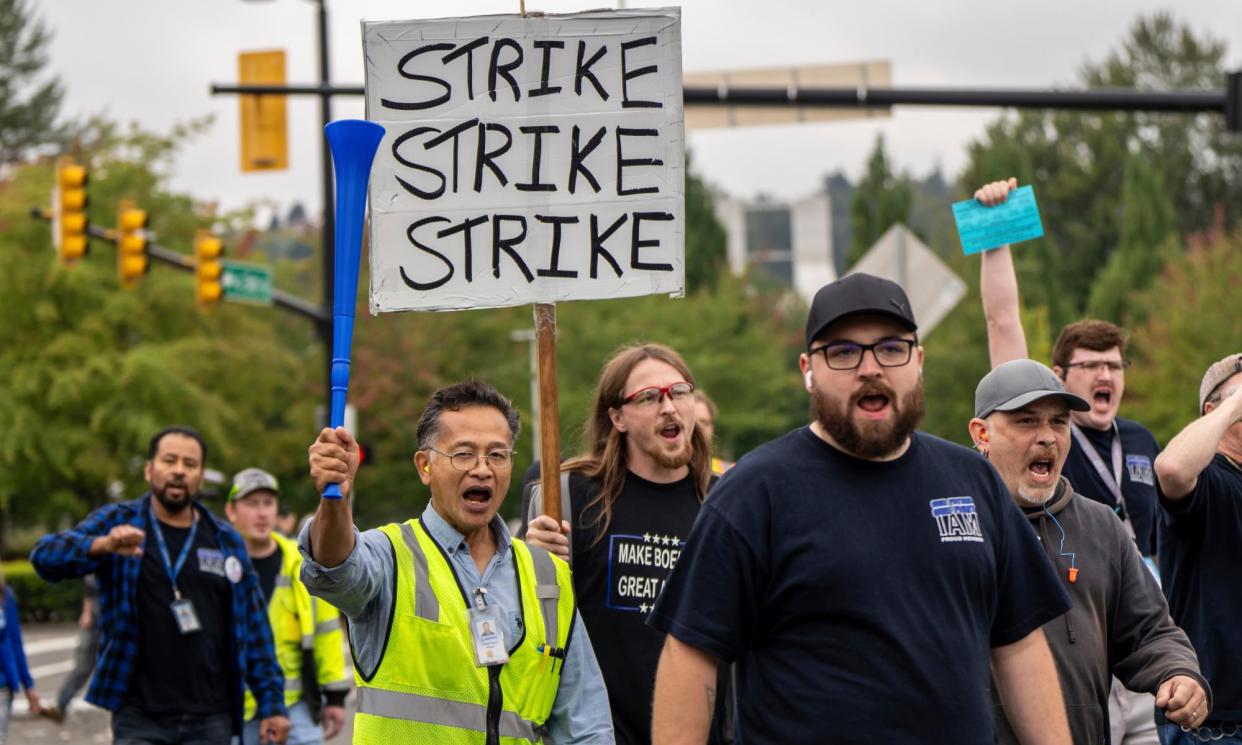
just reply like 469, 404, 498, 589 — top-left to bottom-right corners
975, 179, 1030, 368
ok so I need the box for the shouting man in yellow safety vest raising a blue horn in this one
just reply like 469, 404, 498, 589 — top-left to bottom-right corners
298, 380, 614, 745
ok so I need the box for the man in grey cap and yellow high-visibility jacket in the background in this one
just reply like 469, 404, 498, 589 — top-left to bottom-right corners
225, 468, 350, 745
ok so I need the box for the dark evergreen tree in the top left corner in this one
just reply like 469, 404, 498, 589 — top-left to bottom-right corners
0, 0, 65, 163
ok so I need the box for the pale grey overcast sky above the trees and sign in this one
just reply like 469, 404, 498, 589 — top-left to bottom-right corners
32, 0, 1242, 221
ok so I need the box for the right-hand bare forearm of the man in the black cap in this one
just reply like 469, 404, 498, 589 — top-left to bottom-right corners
992, 628, 1069, 745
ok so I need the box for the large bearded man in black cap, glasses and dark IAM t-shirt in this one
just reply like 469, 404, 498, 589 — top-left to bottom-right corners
648, 274, 1069, 745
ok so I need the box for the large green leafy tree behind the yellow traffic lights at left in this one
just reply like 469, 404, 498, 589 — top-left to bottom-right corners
0, 124, 322, 553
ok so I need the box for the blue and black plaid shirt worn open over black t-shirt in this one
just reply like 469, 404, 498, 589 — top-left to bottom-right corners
30, 493, 286, 733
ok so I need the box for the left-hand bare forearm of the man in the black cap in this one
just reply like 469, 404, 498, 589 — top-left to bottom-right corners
651, 634, 717, 745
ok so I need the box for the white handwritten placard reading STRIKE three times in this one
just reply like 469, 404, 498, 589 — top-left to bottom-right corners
363, 9, 684, 313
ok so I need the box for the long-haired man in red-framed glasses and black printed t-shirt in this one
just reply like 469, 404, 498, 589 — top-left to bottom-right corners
525, 344, 712, 745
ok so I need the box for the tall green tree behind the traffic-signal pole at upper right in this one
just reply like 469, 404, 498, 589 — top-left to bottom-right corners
959, 15, 1242, 327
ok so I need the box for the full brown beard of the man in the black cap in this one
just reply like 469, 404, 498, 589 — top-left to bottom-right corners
811, 381, 927, 459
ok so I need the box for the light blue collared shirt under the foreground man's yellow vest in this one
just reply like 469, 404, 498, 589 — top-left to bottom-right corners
298, 503, 615, 745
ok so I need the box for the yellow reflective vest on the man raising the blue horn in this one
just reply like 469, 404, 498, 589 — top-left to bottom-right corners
354, 520, 574, 745
